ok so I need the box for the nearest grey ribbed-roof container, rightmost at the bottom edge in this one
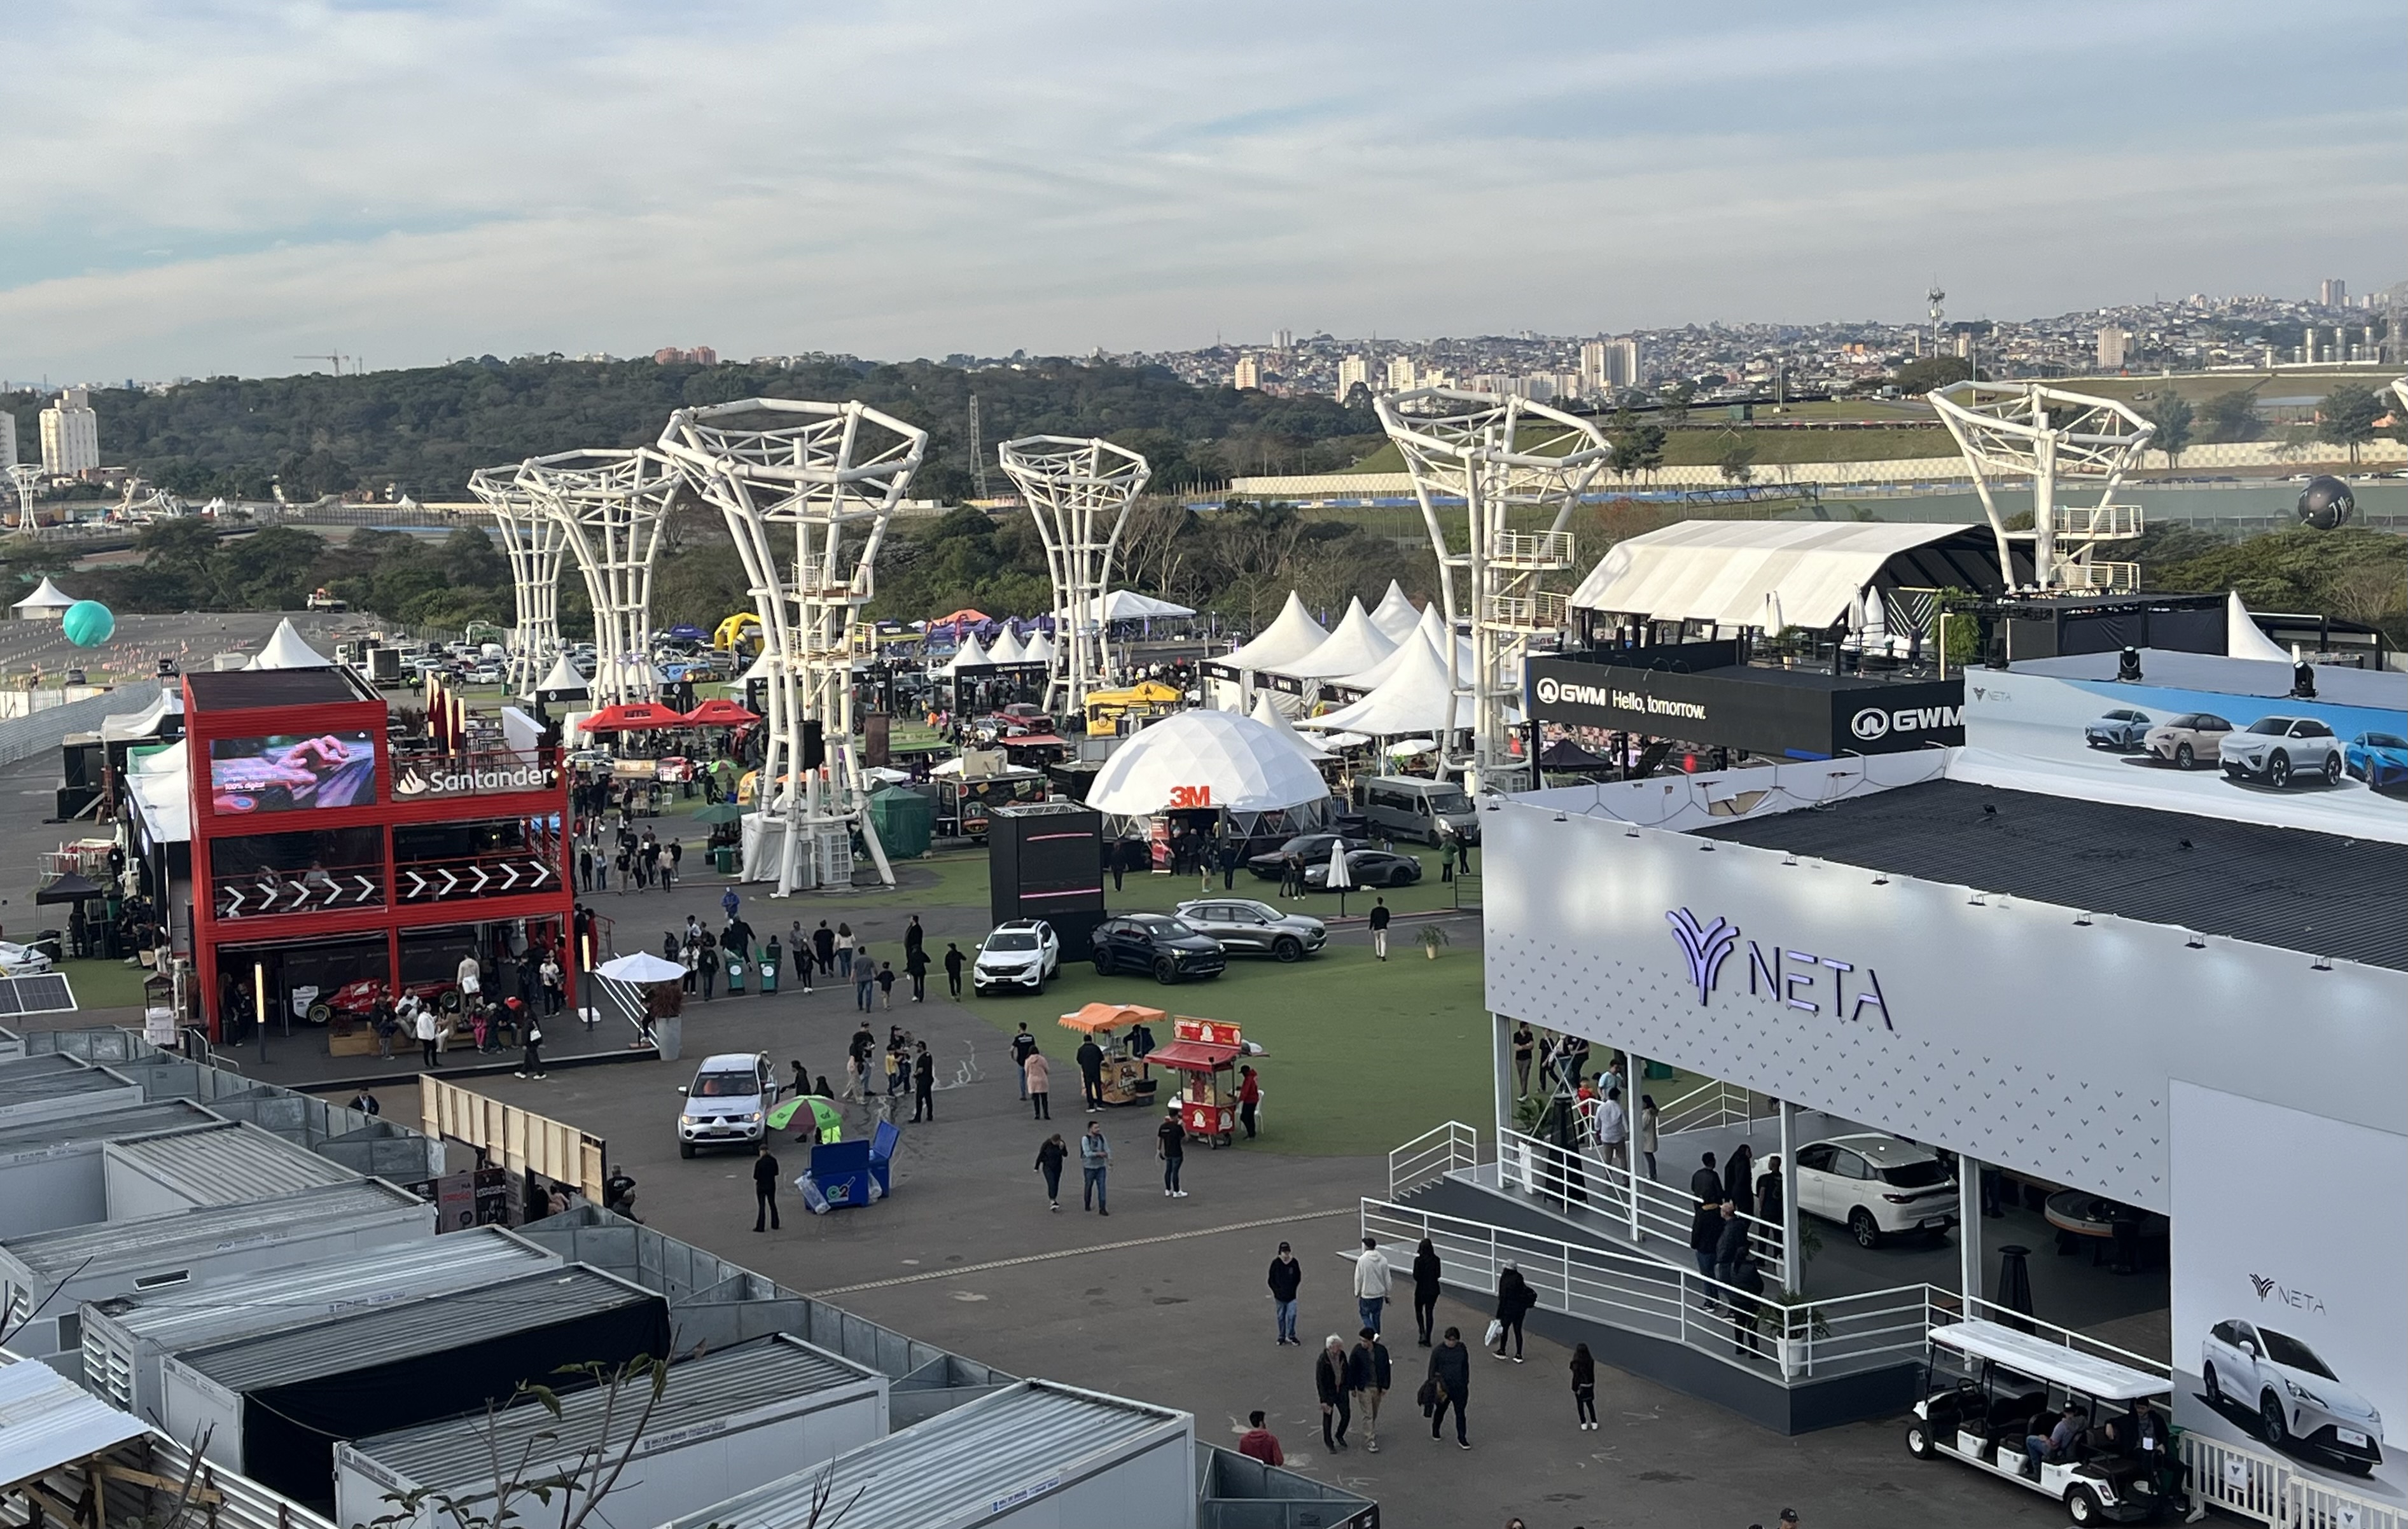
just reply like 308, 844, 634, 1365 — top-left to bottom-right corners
667, 1380, 1197, 1529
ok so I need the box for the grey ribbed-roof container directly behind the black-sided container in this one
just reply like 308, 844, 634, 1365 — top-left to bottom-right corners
82, 1226, 561, 1423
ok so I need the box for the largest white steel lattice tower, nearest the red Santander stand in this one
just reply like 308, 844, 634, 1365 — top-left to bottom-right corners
660, 398, 927, 896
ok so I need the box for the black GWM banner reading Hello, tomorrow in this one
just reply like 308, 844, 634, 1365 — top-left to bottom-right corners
1527, 658, 1965, 759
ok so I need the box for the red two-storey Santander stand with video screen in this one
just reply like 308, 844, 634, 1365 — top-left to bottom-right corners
183, 669, 578, 1052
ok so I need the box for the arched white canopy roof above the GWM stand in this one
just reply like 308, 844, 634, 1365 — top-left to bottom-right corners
1573, 520, 1965, 628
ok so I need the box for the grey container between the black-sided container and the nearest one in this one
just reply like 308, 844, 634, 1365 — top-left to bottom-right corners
335, 1336, 886, 1529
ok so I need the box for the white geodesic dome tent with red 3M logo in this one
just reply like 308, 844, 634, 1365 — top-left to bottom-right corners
1086, 710, 1329, 819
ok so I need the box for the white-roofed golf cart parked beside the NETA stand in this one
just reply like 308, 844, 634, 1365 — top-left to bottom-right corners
1907, 1322, 2177, 1524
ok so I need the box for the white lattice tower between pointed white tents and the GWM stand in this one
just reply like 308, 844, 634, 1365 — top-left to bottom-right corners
1375, 388, 1613, 790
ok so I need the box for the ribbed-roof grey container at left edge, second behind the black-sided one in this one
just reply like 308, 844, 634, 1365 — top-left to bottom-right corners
0, 1177, 436, 1380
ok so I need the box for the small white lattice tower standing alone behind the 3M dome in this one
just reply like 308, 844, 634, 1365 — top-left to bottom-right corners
997, 436, 1153, 710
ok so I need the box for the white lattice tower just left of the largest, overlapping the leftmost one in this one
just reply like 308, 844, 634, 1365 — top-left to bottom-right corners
513, 448, 684, 705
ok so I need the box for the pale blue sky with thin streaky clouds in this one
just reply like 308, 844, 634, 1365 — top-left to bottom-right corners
0, 0, 2408, 383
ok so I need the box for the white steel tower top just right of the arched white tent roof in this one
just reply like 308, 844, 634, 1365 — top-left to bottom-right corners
1929, 383, 2157, 590
